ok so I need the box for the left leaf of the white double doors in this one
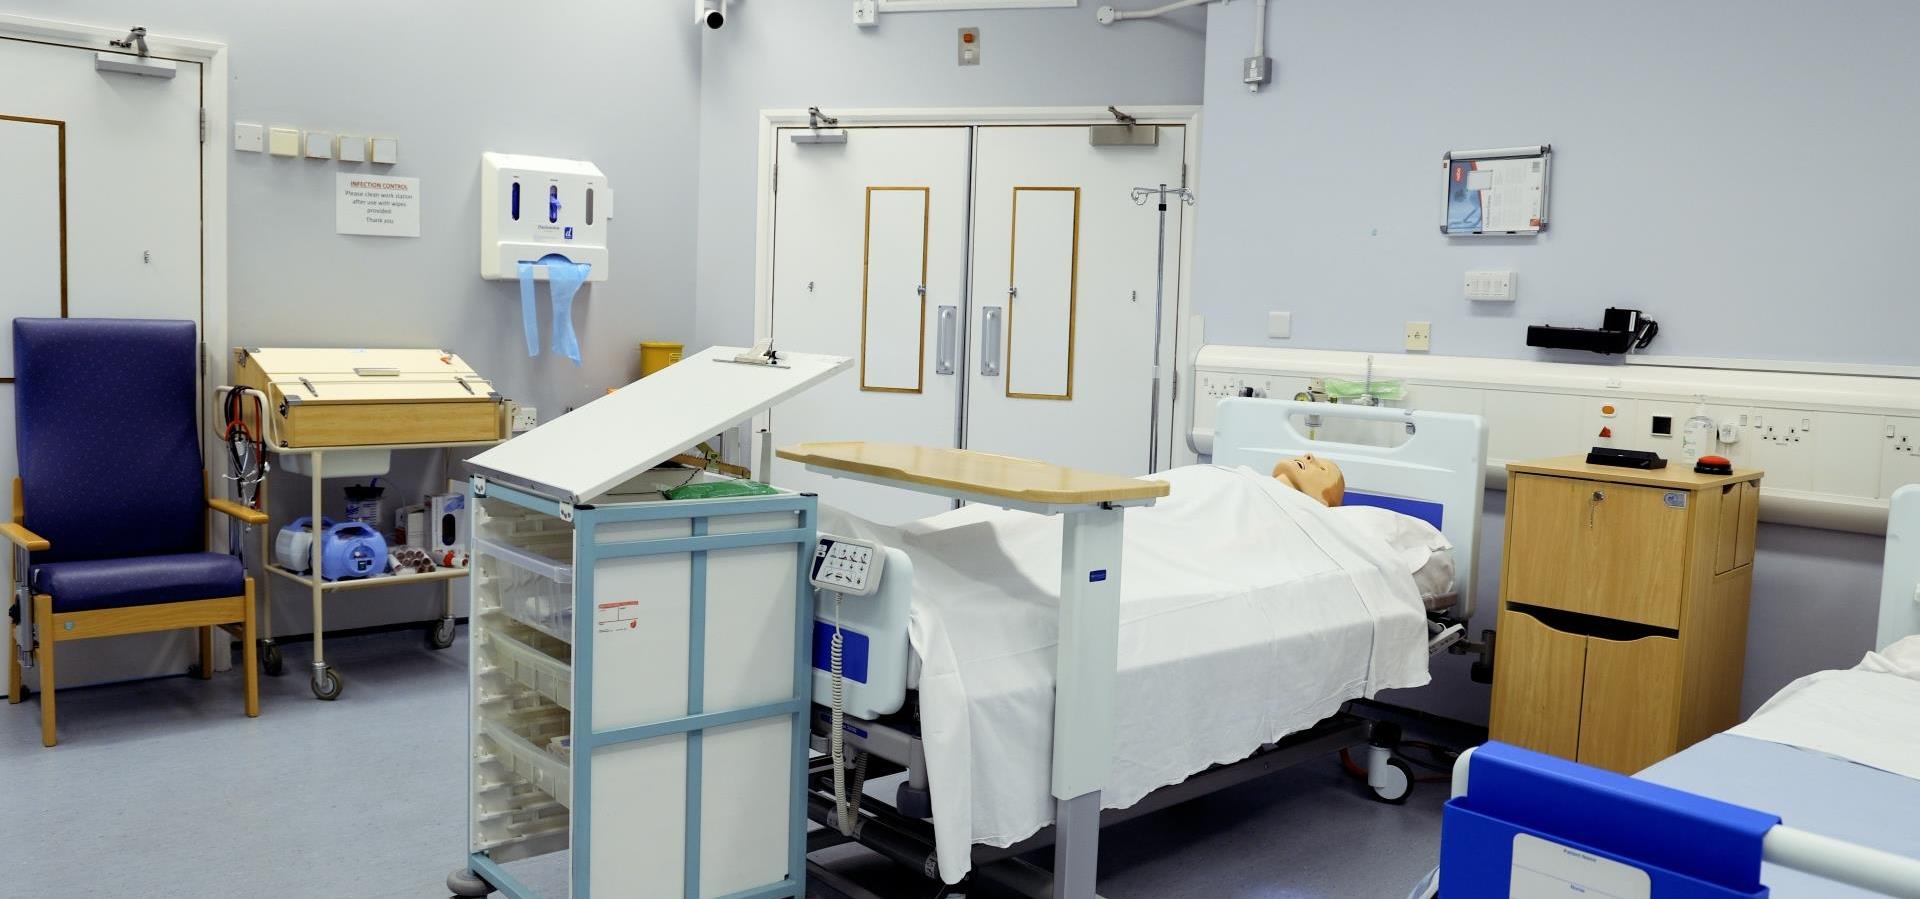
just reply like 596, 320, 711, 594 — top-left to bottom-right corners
772, 127, 972, 522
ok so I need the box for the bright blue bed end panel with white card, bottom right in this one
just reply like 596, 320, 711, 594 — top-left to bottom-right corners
1440, 743, 1780, 899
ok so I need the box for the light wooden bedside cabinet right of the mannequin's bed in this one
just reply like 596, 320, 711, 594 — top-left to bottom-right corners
1490, 455, 1761, 774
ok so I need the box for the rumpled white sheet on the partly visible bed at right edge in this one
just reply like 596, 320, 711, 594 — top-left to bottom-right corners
1728, 636, 1920, 780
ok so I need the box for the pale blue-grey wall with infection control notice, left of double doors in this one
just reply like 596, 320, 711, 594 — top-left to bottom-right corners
0, 0, 706, 641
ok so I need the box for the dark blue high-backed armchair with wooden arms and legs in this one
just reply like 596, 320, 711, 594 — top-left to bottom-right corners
0, 319, 267, 745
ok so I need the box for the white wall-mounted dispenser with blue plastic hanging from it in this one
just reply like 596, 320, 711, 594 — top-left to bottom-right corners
480, 154, 612, 282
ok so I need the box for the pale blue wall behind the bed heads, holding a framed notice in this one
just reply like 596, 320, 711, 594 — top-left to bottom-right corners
1194, 0, 1896, 720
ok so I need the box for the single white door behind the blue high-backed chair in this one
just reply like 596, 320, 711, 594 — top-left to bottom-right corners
0, 31, 202, 686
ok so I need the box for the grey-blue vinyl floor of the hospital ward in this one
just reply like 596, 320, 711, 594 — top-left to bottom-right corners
0, 628, 1446, 899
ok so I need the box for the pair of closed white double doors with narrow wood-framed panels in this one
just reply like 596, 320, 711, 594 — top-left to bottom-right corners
770, 125, 1185, 522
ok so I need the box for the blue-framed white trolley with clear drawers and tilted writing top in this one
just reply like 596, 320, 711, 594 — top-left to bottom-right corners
449, 348, 849, 899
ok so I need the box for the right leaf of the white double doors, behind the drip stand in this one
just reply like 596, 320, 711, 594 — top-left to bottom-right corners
966, 127, 1187, 474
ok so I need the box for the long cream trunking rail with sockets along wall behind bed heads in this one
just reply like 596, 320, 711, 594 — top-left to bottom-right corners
1188, 346, 1920, 534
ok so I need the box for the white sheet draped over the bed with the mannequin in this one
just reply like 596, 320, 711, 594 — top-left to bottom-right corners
822, 465, 1428, 884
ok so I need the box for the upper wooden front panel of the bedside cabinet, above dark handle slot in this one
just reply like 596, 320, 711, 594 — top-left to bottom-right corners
1501, 474, 1692, 628
